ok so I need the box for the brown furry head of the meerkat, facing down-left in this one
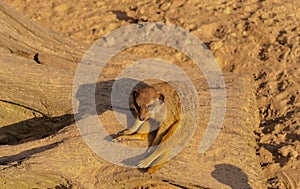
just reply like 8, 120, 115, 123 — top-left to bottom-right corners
132, 87, 164, 121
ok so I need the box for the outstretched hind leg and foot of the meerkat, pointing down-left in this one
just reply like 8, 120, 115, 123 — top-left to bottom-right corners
138, 122, 179, 173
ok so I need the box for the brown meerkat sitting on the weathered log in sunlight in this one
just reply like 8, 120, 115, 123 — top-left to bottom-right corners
117, 83, 181, 174
